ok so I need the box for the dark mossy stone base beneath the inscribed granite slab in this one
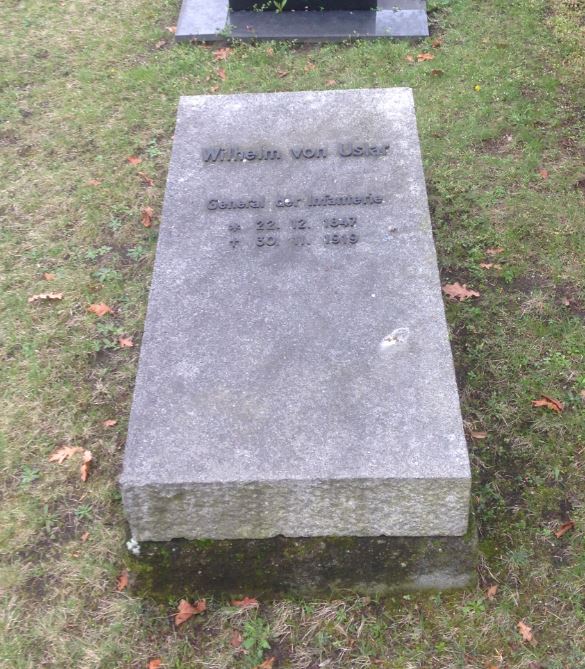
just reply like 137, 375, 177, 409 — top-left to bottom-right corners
128, 528, 477, 600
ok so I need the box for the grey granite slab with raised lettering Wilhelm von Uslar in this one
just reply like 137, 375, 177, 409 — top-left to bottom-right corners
121, 88, 470, 542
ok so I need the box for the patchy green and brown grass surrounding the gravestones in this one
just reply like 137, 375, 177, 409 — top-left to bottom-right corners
0, 0, 585, 669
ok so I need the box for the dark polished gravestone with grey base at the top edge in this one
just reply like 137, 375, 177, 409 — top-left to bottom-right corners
175, 0, 429, 42
